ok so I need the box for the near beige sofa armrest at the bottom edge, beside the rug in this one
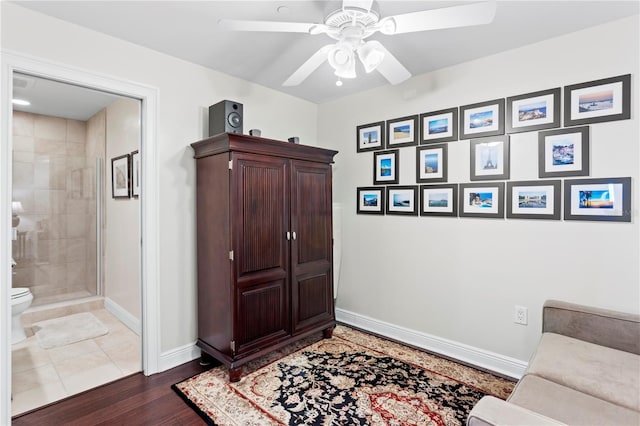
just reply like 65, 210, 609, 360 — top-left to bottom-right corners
467, 396, 564, 426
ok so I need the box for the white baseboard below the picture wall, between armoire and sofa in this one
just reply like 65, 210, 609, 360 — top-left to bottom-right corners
336, 309, 527, 379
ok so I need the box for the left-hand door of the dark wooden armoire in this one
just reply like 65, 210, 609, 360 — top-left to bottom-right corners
230, 153, 291, 355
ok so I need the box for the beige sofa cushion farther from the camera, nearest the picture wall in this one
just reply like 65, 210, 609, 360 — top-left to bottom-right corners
527, 333, 640, 411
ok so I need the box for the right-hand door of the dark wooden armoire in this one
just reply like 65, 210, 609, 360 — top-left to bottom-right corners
291, 161, 334, 333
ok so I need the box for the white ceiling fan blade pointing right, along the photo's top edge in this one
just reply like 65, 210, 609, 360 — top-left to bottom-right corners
378, 0, 496, 34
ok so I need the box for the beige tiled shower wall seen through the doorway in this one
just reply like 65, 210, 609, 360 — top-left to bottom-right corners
13, 111, 104, 306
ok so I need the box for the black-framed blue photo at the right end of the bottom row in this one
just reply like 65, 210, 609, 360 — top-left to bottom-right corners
564, 177, 631, 222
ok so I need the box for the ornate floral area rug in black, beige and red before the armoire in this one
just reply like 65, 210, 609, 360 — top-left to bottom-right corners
173, 325, 514, 426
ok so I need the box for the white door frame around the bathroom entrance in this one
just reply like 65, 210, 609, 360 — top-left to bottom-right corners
0, 50, 160, 424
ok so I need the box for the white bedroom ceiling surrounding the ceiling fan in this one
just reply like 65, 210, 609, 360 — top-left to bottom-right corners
8, 0, 640, 118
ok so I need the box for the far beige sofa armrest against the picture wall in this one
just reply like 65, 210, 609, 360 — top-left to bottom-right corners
542, 300, 640, 355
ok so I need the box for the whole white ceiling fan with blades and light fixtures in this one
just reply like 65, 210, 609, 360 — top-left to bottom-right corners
218, 0, 496, 86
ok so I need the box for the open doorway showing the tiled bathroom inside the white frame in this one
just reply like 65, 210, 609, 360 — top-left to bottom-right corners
11, 73, 141, 415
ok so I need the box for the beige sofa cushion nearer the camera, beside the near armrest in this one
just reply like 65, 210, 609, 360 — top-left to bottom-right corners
508, 374, 640, 426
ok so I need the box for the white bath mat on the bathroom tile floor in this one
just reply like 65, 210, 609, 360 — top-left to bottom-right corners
32, 312, 109, 349
